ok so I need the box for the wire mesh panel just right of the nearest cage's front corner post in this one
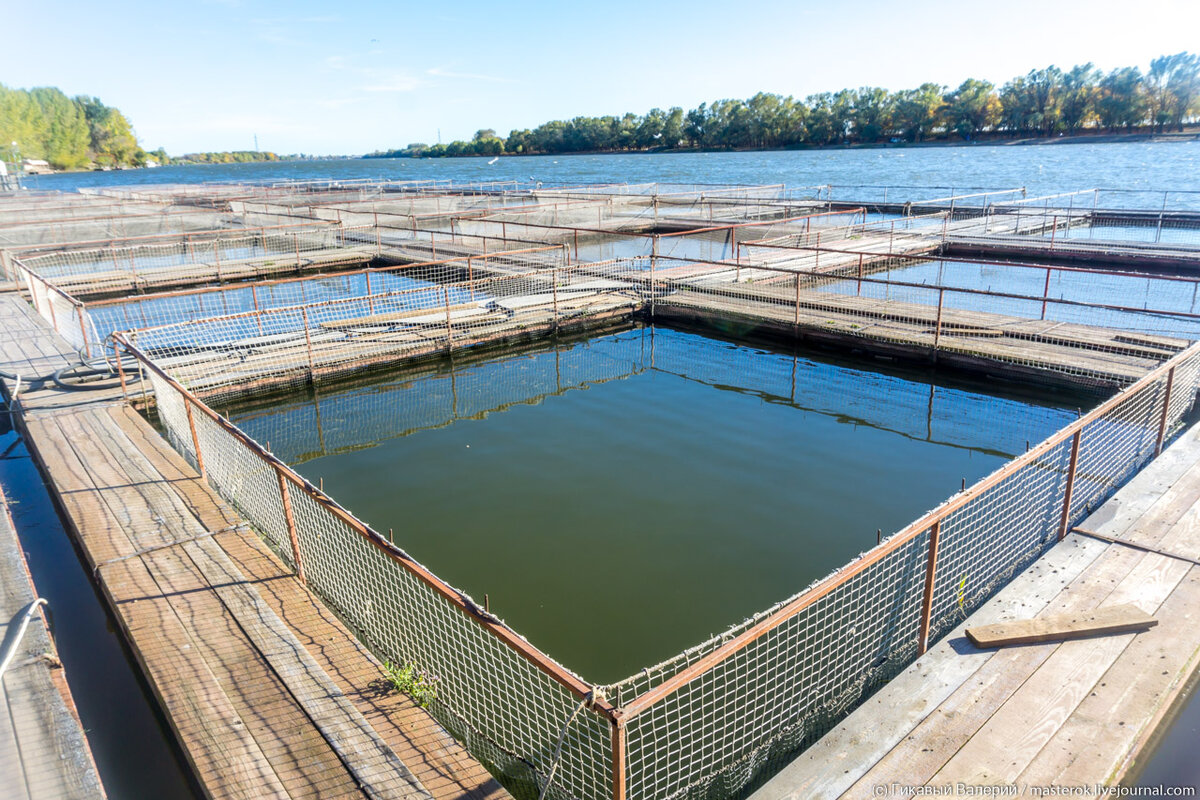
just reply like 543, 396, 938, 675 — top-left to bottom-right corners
626, 533, 929, 800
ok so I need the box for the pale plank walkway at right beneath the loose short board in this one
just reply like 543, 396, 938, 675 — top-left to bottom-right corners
752, 426, 1200, 800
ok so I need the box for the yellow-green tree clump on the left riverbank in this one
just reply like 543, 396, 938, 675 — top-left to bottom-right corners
0, 84, 148, 169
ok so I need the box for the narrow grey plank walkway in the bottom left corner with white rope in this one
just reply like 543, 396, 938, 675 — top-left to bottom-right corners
0, 491, 104, 800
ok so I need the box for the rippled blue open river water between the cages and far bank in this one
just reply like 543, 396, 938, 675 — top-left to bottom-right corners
31, 142, 1200, 207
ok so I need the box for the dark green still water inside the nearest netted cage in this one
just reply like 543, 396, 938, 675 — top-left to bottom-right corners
223, 327, 1080, 681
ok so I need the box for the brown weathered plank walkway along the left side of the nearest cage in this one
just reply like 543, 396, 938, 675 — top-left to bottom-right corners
0, 294, 506, 800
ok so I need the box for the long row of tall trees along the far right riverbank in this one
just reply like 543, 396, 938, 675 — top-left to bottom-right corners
366, 53, 1200, 158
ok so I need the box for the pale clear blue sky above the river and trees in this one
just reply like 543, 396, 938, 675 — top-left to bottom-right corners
0, 0, 1200, 154
